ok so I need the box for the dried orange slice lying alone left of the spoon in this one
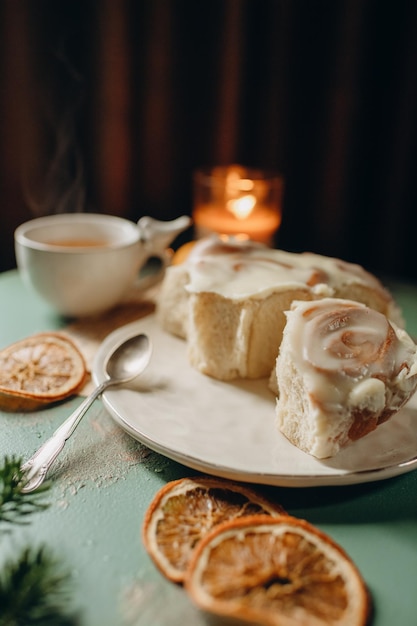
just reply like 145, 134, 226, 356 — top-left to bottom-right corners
0, 333, 87, 411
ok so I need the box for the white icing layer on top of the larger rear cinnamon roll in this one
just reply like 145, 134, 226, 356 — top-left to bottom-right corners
185, 236, 391, 302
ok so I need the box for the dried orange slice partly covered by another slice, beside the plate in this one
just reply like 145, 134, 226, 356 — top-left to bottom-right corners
142, 477, 284, 582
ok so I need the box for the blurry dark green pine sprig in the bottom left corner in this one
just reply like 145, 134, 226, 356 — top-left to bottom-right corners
0, 548, 76, 626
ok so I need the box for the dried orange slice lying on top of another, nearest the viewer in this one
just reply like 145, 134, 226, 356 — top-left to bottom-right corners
185, 515, 370, 626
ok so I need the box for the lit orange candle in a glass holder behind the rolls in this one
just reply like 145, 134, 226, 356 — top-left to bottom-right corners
193, 165, 283, 245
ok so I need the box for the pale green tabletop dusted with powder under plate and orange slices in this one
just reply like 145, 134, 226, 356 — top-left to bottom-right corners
0, 271, 417, 626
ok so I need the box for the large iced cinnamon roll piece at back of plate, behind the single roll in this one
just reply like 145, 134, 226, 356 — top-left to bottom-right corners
158, 236, 402, 380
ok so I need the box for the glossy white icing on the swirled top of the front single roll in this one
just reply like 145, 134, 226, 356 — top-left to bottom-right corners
287, 298, 417, 415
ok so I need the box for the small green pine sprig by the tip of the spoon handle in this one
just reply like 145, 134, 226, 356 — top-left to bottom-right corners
0, 456, 49, 524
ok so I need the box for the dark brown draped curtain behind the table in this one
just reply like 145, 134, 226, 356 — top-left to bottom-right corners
0, 0, 417, 280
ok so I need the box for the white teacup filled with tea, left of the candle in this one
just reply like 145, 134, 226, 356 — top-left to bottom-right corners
15, 213, 191, 317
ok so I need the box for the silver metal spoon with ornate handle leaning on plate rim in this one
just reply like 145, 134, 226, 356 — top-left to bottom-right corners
21, 334, 152, 493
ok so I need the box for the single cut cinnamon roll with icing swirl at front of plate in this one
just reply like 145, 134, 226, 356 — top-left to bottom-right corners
276, 298, 417, 458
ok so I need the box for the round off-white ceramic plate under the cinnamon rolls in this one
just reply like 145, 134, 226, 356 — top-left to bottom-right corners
93, 315, 417, 487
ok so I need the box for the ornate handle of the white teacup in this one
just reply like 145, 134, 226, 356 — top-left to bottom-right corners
136, 215, 192, 289
